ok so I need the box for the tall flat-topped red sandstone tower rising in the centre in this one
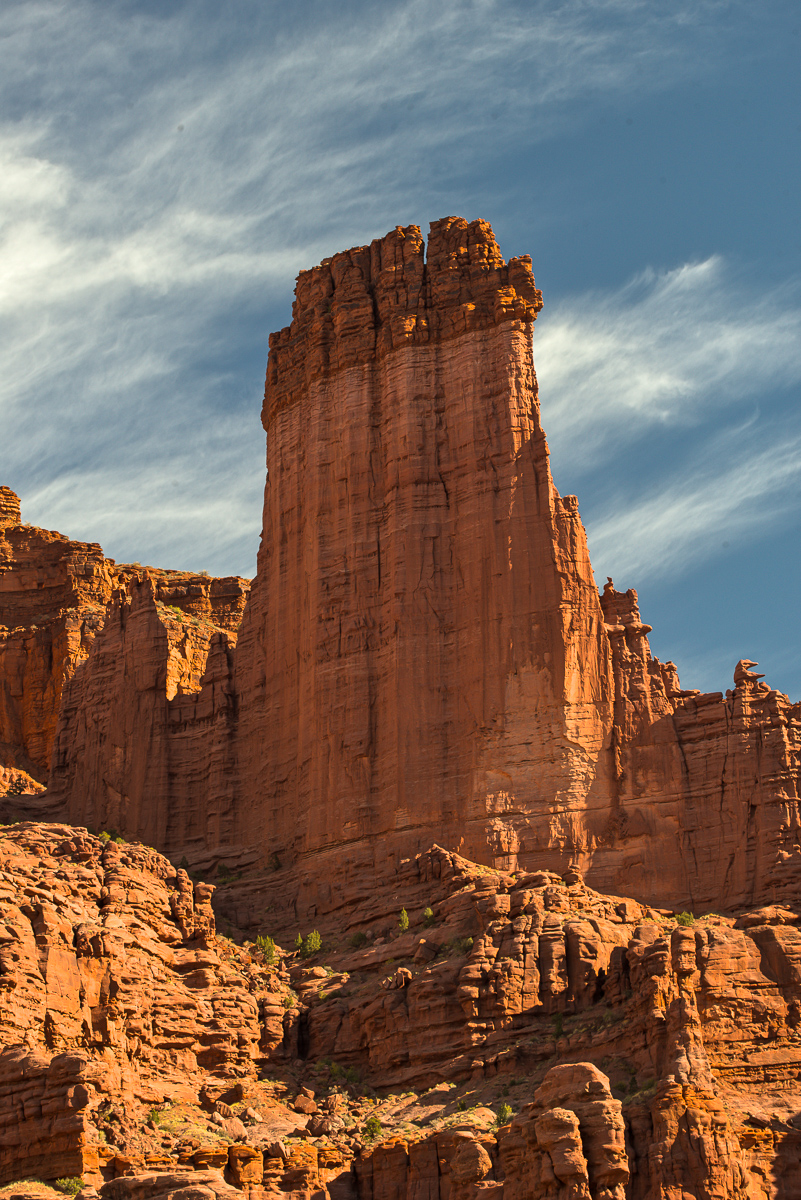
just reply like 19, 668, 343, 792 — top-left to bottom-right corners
236, 218, 613, 862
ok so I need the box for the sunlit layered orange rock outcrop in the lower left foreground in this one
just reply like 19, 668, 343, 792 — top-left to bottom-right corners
0, 824, 287, 1183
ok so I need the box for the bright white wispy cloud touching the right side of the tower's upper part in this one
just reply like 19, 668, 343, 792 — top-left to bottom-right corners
535, 257, 801, 466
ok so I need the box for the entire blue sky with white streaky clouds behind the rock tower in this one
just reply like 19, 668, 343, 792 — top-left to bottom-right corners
0, 0, 801, 698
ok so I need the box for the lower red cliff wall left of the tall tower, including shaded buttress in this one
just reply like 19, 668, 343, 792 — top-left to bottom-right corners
0, 488, 249, 845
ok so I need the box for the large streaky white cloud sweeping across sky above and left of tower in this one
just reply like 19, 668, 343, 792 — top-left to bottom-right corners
0, 0, 767, 571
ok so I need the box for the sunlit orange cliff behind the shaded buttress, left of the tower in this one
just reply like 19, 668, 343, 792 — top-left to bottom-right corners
0, 487, 249, 796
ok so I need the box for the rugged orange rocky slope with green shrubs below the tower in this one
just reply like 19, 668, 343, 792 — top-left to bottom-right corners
0, 823, 801, 1200
